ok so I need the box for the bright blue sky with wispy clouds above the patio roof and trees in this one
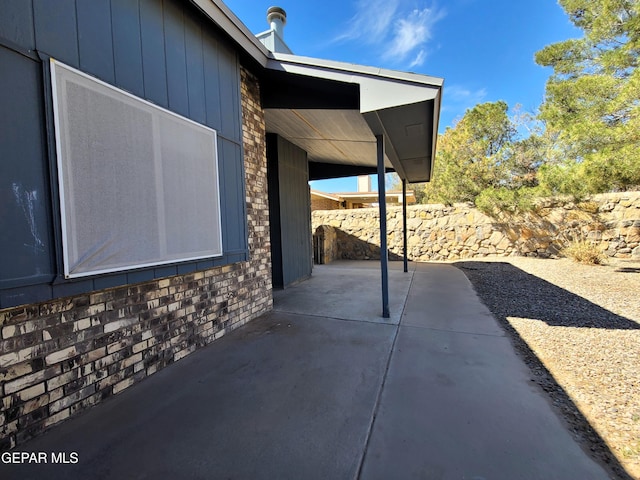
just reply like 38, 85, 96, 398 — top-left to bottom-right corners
225, 0, 582, 191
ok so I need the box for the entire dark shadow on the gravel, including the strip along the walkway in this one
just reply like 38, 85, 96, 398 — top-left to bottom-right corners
453, 261, 640, 480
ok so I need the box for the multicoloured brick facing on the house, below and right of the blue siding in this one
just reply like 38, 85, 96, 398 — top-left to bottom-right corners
0, 69, 273, 450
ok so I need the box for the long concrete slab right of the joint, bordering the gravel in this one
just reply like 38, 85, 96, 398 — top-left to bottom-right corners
361, 265, 607, 480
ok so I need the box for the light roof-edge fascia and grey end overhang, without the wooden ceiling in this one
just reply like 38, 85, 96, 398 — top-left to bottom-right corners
191, 0, 444, 183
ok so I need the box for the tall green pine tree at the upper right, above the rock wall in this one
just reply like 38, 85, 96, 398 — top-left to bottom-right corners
536, 0, 640, 193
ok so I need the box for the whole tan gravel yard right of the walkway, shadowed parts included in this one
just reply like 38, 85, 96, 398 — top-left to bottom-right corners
454, 257, 640, 480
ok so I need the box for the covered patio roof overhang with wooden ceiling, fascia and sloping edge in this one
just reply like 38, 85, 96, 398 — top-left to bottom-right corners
192, 0, 443, 183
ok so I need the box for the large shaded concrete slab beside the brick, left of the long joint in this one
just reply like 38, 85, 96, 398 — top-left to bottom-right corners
0, 314, 395, 480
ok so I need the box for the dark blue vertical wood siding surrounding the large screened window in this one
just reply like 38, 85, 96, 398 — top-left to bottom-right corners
0, 0, 248, 308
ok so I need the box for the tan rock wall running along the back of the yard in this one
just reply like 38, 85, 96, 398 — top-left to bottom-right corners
312, 192, 640, 261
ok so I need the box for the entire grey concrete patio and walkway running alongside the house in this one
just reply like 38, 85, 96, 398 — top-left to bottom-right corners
0, 262, 609, 480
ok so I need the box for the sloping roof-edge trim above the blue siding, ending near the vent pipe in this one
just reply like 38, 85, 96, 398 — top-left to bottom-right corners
191, 0, 271, 67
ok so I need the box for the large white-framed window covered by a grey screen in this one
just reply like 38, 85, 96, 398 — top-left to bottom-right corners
51, 60, 222, 277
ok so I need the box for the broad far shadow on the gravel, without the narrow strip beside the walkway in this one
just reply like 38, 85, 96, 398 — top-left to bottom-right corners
454, 261, 640, 330
